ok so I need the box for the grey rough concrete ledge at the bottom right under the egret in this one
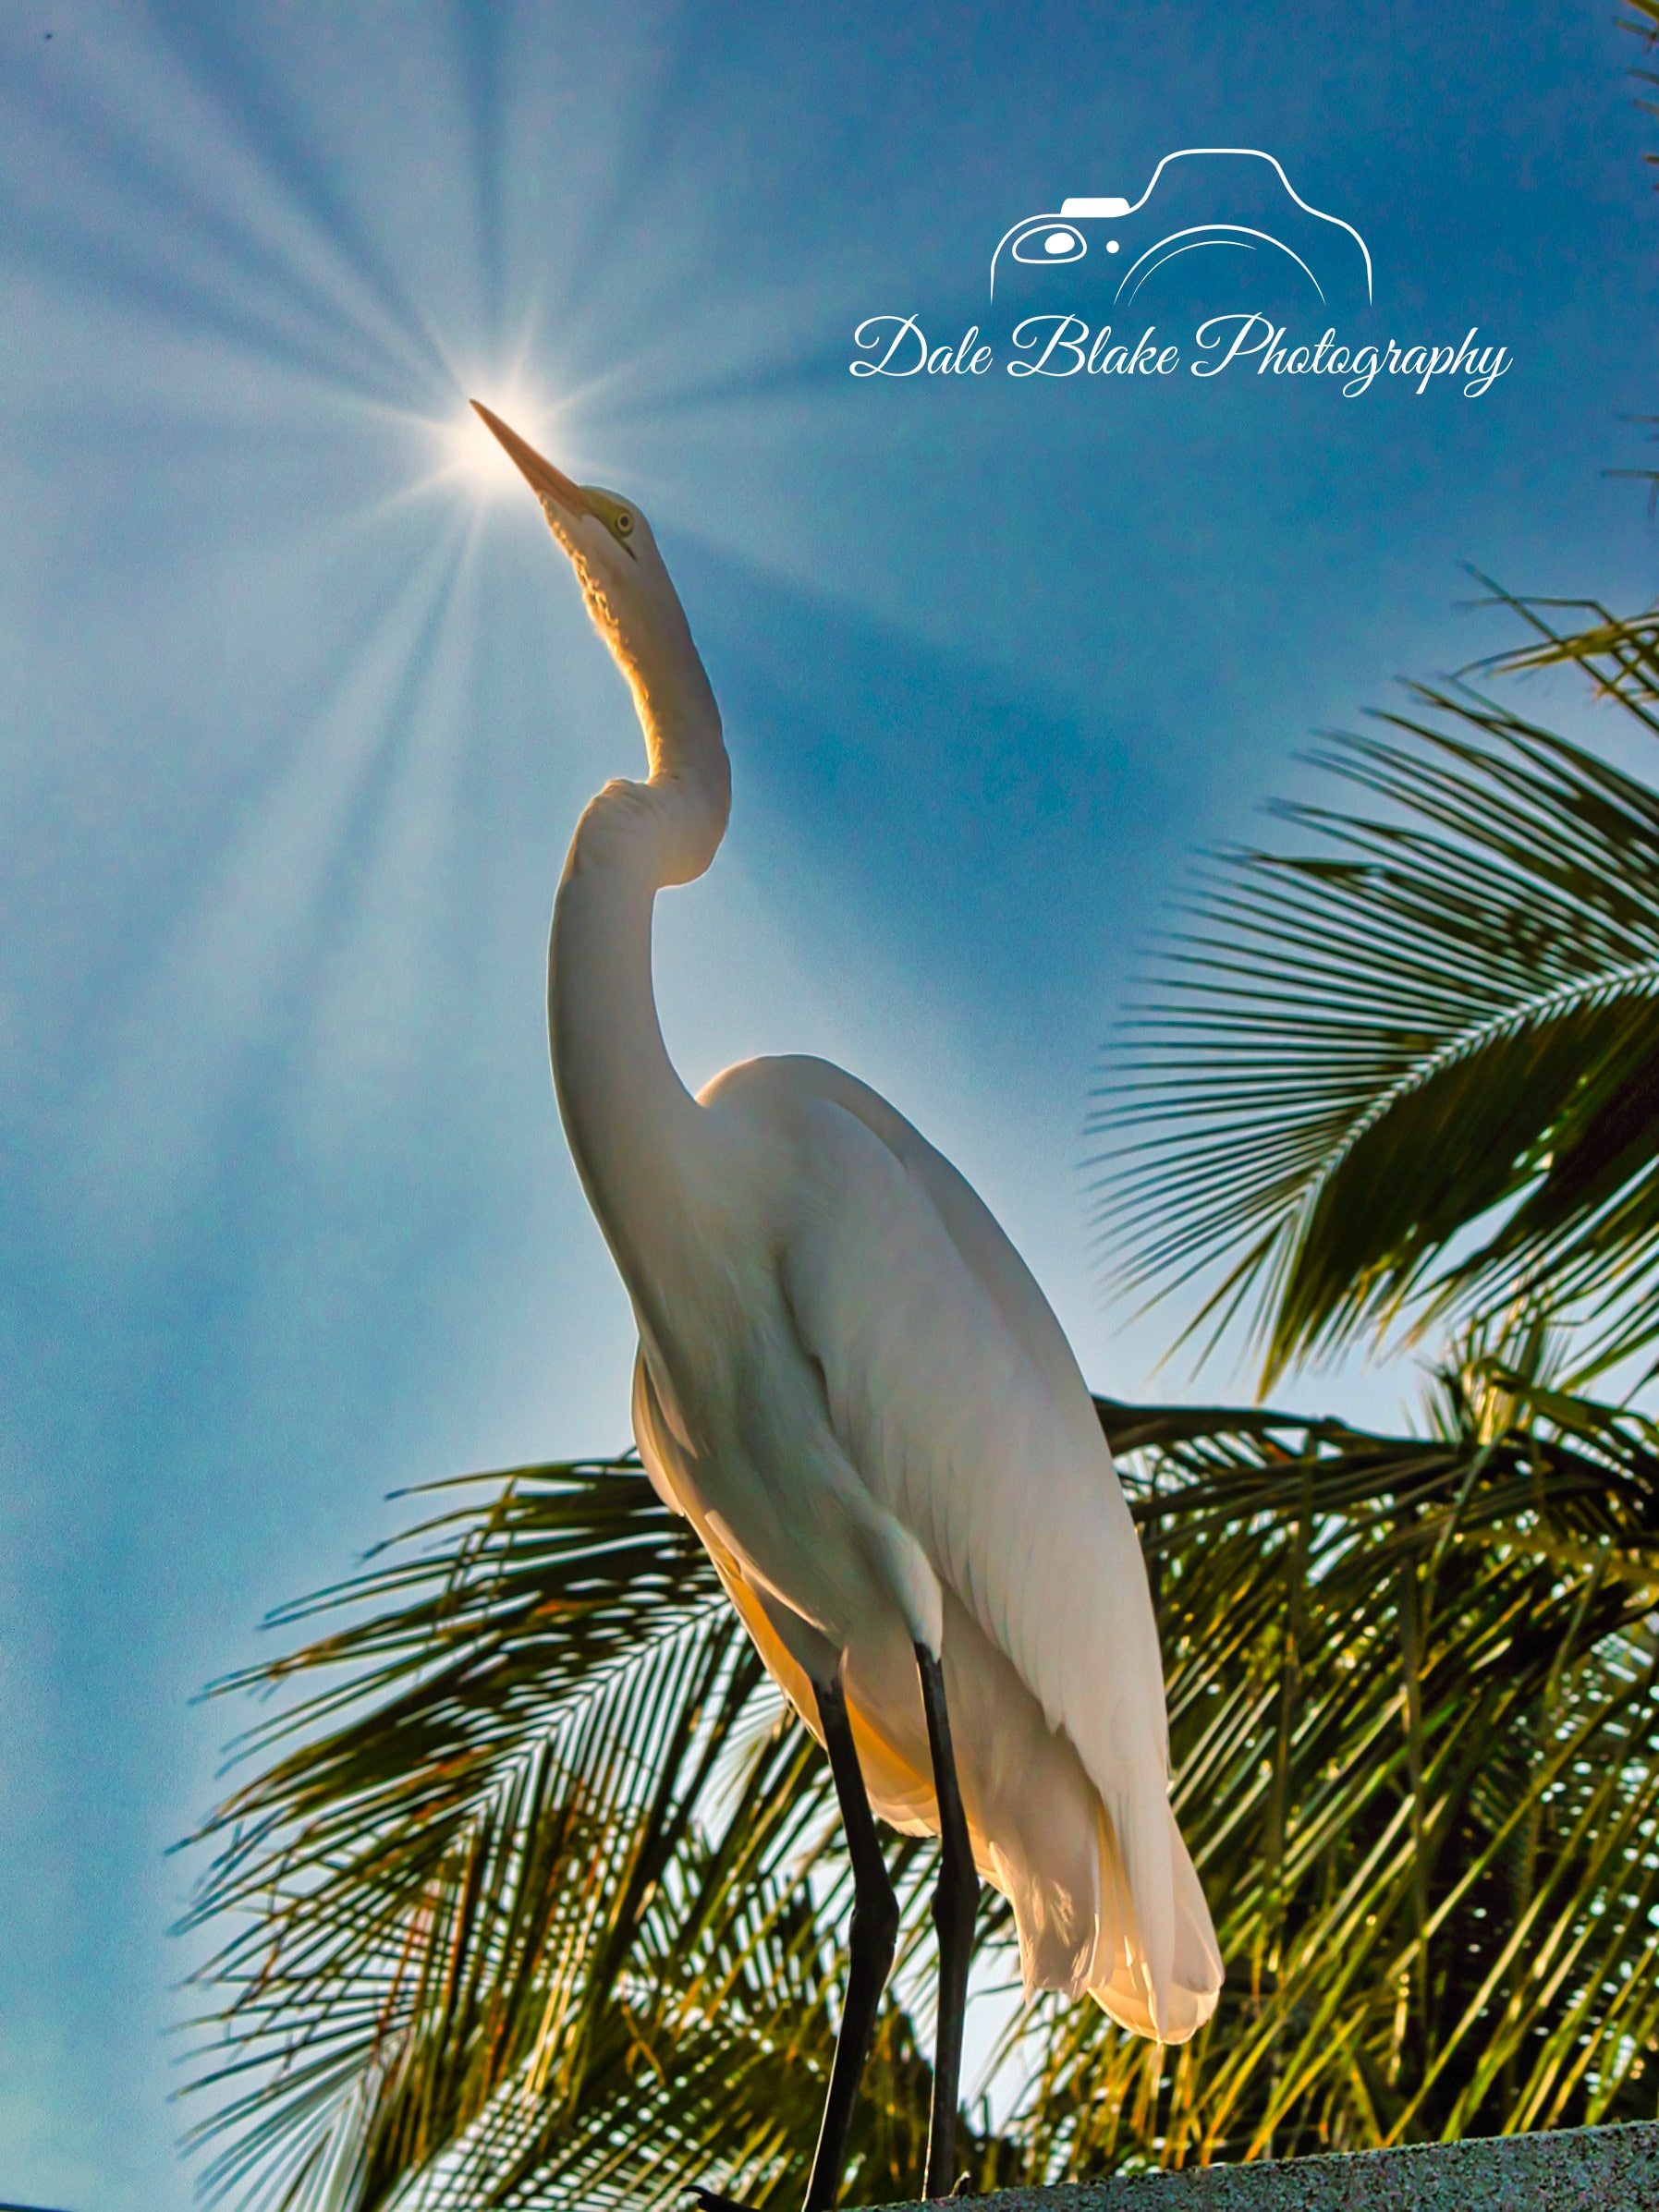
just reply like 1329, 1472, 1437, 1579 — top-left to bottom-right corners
862, 2119, 1659, 2212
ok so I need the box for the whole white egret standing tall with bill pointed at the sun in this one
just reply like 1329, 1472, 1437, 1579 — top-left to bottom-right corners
478, 407, 1221, 2212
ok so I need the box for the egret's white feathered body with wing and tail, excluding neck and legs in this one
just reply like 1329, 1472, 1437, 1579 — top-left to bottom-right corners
630, 1060, 1221, 2042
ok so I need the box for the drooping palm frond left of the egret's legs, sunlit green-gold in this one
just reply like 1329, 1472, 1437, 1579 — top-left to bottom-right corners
188, 1462, 986, 2212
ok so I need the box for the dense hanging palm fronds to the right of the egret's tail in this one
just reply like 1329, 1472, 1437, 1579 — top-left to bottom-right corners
1006, 1345, 1659, 2179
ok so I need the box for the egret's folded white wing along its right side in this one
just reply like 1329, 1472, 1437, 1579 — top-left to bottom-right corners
708, 1060, 1219, 2035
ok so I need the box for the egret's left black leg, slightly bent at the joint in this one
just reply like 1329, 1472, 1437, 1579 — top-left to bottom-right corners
692, 1677, 898, 2212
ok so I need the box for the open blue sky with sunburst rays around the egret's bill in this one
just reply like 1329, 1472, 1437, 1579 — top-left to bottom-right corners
0, 0, 1659, 2212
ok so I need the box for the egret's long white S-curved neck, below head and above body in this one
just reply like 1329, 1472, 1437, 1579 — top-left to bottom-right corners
549, 602, 732, 1303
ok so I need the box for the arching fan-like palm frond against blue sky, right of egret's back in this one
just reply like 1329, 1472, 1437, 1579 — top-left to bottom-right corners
1092, 688, 1659, 1382
